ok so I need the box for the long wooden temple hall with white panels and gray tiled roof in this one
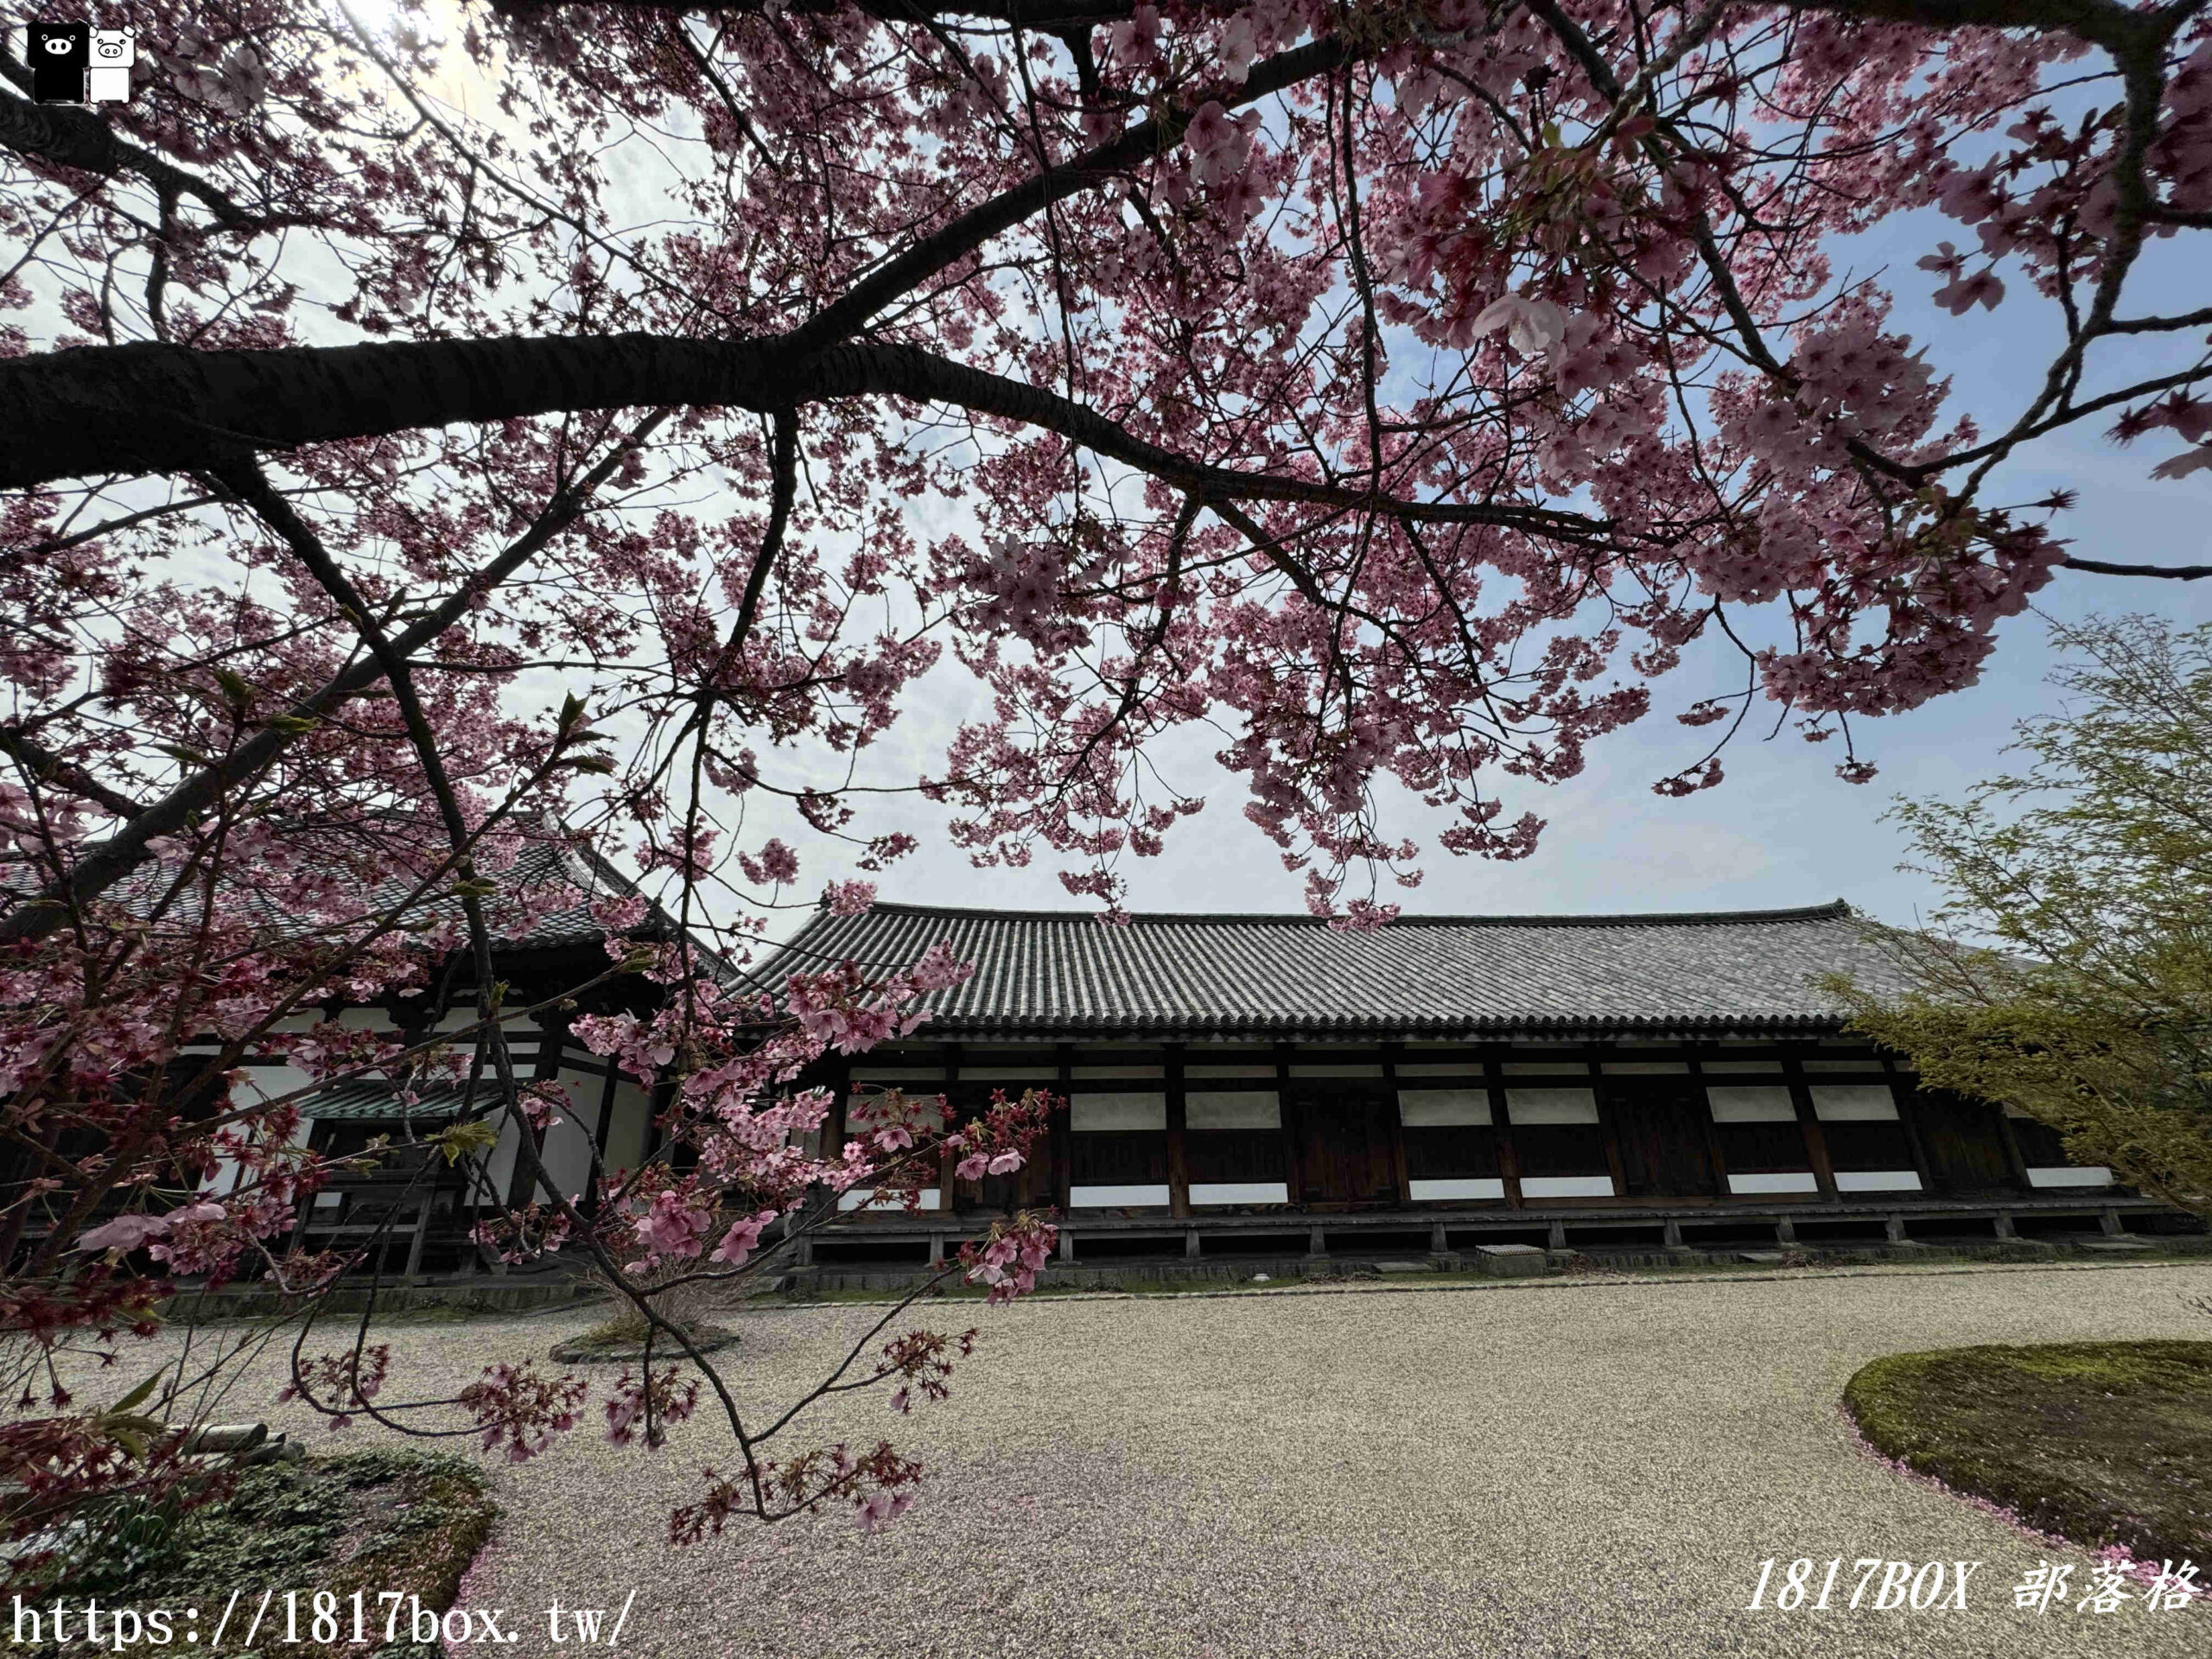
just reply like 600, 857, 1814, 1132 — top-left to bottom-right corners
757, 902, 2188, 1265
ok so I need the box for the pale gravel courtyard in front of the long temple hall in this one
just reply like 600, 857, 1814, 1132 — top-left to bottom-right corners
107, 1265, 2212, 1659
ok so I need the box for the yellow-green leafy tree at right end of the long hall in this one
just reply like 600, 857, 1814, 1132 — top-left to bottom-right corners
1827, 617, 2212, 1214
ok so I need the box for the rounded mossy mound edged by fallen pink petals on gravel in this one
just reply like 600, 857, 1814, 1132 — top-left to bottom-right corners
1842, 1343, 2212, 1561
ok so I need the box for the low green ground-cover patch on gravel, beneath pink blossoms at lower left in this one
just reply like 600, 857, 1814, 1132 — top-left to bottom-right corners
47, 1446, 498, 1659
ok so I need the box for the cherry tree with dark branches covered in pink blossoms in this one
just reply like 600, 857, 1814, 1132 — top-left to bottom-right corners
0, 0, 2212, 1537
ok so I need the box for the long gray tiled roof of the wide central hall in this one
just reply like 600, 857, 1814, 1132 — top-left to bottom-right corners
747, 900, 1896, 1038
